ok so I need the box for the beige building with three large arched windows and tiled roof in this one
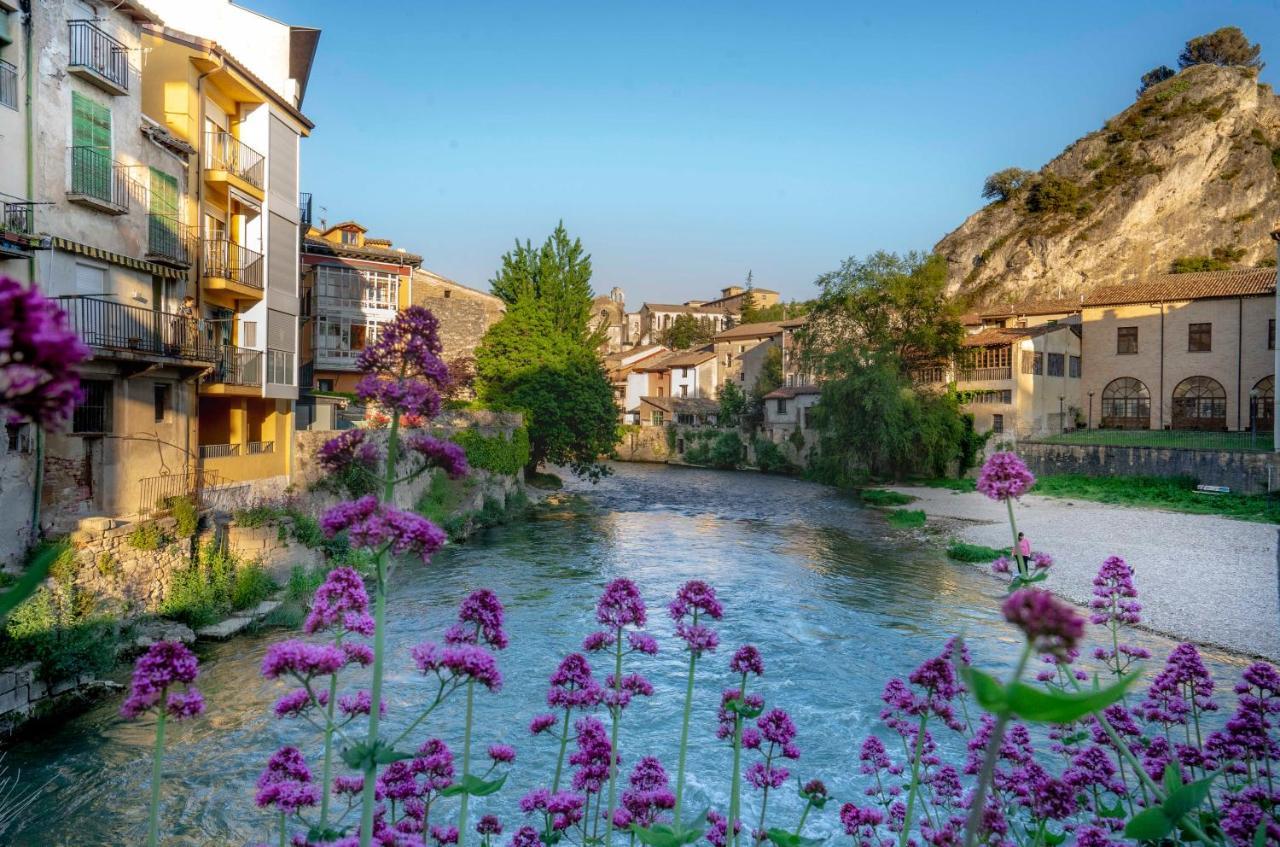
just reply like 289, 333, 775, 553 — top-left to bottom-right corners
1082, 269, 1276, 431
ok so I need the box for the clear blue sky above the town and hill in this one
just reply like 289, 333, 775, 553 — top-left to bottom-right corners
241, 0, 1280, 307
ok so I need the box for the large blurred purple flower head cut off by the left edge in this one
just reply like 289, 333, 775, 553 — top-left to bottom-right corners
0, 276, 90, 430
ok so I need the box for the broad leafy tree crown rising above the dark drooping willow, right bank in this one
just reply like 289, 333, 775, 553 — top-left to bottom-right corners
797, 251, 964, 375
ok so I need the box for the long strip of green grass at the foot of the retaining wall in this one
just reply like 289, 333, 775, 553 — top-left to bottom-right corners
1032, 473, 1280, 523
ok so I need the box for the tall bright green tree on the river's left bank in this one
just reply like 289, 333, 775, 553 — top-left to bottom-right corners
476, 223, 618, 479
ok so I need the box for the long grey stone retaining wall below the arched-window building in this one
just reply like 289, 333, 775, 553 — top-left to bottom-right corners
1016, 441, 1280, 494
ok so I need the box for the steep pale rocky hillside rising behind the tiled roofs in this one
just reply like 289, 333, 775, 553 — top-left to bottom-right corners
934, 65, 1280, 305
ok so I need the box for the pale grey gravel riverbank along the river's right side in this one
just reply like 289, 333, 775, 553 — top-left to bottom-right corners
893, 486, 1280, 660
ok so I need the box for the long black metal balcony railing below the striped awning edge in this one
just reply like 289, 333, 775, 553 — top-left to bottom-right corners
56, 296, 218, 362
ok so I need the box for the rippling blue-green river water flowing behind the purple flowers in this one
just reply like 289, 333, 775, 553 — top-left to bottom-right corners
0, 464, 1243, 847
